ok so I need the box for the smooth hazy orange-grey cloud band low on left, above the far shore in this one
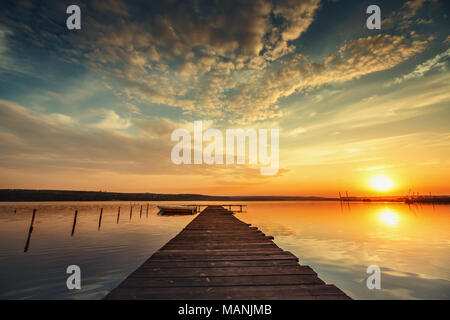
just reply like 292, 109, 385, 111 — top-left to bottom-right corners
0, 100, 286, 183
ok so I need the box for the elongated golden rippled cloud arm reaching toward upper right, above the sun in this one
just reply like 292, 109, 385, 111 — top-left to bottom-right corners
229, 34, 428, 121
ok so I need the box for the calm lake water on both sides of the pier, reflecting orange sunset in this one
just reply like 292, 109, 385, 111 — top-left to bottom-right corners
0, 202, 450, 299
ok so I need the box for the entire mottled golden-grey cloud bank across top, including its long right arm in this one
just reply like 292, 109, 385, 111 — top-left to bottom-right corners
0, 0, 436, 124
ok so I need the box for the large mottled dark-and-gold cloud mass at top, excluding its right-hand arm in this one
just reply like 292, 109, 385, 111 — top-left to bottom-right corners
1, 0, 320, 118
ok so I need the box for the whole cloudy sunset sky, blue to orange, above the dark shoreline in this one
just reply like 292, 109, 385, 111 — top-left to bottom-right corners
0, 0, 450, 196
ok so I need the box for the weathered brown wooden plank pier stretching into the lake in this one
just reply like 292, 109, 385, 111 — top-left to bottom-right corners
105, 206, 350, 300
